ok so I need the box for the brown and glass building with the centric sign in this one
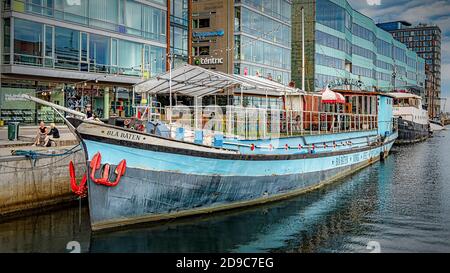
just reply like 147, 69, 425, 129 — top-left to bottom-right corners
192, 0, 291, 84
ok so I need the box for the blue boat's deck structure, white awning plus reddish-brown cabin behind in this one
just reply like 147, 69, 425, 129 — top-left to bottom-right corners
134, 65, 390, 141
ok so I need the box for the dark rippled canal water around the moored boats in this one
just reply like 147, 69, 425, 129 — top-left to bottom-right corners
0, 130, 450, 253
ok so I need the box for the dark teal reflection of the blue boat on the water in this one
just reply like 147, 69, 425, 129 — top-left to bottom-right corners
91, 163, 384, 252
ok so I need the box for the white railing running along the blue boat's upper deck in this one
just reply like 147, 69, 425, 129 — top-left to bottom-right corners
136, 105, 378, 139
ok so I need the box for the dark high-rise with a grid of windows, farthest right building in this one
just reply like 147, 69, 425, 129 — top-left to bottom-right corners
378, 21, 441, 118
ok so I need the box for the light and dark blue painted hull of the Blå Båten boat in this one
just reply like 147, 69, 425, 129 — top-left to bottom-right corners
76, 121, 397, 230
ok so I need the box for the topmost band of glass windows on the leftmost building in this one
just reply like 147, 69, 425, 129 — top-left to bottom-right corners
6, 0, 167, 43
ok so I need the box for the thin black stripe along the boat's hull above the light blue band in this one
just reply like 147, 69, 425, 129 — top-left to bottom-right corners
80, 133, 395, 161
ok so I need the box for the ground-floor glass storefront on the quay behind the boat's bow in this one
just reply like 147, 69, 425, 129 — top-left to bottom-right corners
0, 79, 133, 124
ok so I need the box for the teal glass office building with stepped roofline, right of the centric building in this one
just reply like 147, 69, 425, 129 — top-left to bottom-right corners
292, 0, 425, 92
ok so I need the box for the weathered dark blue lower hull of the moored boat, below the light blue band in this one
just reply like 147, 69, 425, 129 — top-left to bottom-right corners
89, 157, 386, 230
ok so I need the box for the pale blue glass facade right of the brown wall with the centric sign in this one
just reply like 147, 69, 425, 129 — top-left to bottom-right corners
234, 0, 291, 84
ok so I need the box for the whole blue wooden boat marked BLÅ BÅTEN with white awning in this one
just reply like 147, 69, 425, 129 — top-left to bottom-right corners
25, 66, 398, 230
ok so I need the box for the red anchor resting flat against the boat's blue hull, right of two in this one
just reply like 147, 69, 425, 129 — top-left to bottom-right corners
90, 152, 127, 187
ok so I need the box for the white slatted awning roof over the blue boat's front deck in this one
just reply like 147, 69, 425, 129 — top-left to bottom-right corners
134, 64, 300, 97
